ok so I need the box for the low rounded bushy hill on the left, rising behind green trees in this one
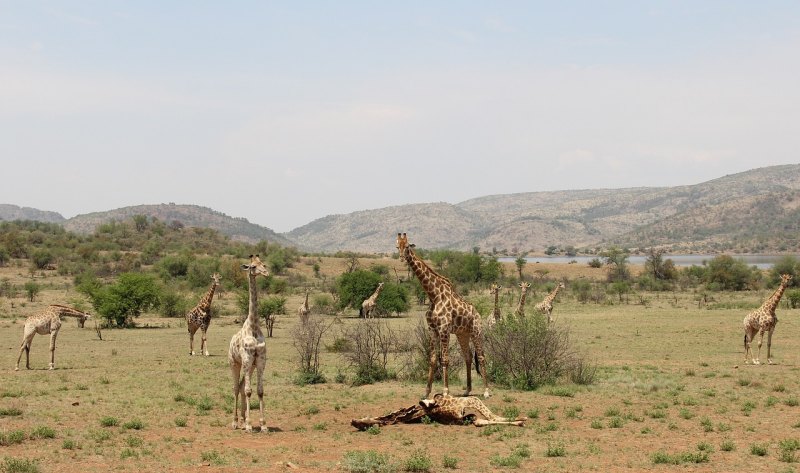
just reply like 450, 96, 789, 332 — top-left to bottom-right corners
63, 204, 296, 246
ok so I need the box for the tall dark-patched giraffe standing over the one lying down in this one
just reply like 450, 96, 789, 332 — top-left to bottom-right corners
397, 233, 489, 398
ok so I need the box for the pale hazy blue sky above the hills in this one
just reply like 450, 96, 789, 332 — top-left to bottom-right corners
0, 0, 800, 232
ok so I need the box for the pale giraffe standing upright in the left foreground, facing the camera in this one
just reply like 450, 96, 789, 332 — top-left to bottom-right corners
228, 255, 269, 432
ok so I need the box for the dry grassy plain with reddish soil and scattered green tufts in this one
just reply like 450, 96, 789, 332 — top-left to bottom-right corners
0, 258, 800, 472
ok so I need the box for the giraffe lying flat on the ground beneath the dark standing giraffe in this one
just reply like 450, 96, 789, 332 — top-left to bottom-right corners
350, 394, 527, 430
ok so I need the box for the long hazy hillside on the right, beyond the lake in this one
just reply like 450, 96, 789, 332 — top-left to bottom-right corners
286, 164, 800, 253
